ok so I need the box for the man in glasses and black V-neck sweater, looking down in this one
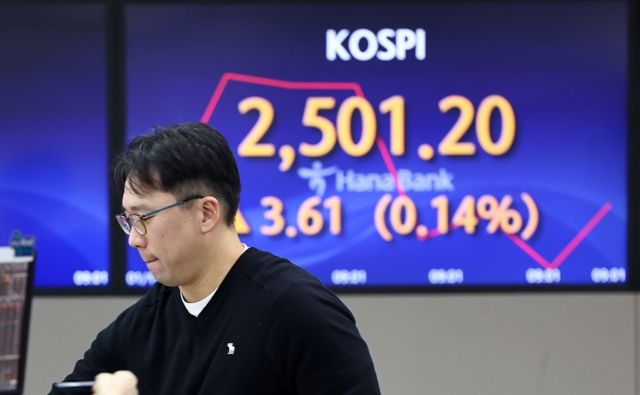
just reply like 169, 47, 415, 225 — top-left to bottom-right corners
51, 123, 380, 395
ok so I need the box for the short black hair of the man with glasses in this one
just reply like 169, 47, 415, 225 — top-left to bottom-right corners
113, 122, 241, 226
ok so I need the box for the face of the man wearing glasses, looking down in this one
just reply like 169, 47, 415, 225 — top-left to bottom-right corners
122, 180, 201, 286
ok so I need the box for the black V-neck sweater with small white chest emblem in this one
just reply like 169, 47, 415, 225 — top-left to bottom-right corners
51, 248, 380, 395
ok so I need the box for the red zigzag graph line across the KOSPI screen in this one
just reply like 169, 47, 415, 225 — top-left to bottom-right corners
200, 73, 612, 269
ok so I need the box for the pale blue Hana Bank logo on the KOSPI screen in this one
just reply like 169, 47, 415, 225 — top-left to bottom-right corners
298, 160, 455, 196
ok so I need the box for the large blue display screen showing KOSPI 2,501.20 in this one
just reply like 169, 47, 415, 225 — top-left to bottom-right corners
126, 2, 628, 287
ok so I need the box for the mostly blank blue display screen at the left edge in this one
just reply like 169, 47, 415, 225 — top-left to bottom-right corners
0, 4, 109, 290
